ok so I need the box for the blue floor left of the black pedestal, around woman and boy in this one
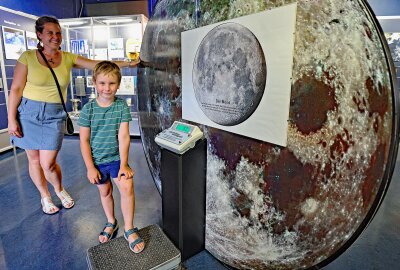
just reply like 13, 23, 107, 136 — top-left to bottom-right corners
0, 139, 161, 270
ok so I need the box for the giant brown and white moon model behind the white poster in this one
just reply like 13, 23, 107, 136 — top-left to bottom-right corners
138, 0, 398, 269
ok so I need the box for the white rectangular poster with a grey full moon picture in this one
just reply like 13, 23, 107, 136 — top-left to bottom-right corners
181, 4, 297, 146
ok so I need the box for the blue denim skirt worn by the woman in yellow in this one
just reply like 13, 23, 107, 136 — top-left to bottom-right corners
10, 97, 67, 150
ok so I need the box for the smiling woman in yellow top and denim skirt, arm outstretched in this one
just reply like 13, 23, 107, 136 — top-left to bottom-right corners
8, 16, 139, 215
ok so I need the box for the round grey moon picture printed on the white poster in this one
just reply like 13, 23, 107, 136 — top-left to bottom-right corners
192, 23, 266, 126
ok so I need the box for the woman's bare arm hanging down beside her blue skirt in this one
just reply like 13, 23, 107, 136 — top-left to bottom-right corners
8, 61, 28, 138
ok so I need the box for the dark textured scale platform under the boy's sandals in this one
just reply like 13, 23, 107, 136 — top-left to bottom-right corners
87, 225, 181, 270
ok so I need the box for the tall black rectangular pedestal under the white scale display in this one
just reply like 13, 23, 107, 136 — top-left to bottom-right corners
161, 139, 207, 261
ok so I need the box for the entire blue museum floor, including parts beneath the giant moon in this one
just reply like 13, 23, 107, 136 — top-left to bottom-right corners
0, 137, 400, 270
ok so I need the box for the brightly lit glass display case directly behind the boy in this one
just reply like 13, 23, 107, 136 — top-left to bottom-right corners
60, 15, 147, 136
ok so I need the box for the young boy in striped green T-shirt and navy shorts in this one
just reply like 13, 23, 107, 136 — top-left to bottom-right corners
78, 61, 144, 253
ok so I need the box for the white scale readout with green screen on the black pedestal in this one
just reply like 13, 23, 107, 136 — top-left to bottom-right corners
155, 121, 203, 155
